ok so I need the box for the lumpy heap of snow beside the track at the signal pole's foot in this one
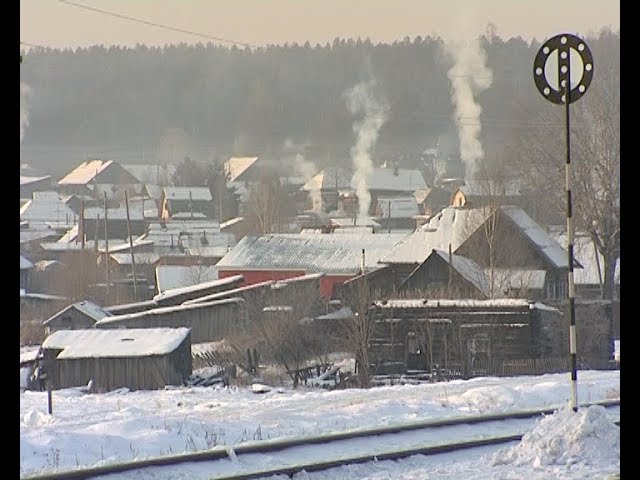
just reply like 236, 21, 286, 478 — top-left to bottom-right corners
491, 405, 620, 468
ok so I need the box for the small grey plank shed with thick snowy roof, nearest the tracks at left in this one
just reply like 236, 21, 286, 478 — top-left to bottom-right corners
42, 328, 192, 392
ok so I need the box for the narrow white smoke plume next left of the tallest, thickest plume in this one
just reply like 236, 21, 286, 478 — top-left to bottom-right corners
345, 80, 389, 217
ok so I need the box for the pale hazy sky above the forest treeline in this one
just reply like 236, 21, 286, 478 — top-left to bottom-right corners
20, 0, 620, 48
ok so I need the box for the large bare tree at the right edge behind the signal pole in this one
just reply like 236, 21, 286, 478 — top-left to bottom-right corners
514, 31, 620, 299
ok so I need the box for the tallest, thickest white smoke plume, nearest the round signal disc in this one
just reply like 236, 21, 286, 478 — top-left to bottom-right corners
447, 34, 493, 179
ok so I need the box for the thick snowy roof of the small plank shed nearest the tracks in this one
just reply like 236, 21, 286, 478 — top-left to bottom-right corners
42, 328, 190, 360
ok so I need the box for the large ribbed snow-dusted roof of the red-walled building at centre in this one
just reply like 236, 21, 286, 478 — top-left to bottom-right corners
216, 233, 405, 275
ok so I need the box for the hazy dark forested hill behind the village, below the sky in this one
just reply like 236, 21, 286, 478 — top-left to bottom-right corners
20, 30, 620, 174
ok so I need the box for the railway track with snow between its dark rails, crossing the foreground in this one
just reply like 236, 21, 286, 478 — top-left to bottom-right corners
21, 400, 620, 480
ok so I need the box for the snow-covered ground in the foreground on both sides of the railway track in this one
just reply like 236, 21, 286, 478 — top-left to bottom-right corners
20, 370, 620, 480
